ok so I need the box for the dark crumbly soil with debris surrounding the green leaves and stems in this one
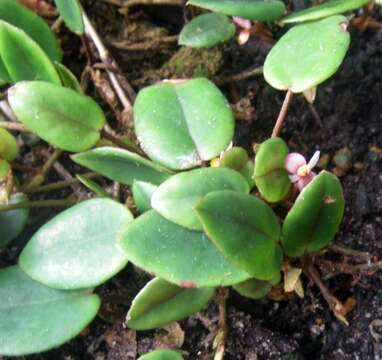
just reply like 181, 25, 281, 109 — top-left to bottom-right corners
0, 1, 382, 360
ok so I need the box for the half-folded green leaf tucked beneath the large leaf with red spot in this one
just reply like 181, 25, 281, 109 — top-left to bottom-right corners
127, 278, 215, 330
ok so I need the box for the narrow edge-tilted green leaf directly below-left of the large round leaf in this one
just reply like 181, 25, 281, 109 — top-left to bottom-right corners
72, 147, 171, 185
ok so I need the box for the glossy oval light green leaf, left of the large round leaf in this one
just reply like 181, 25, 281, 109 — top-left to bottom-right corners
8, 81, 106, 152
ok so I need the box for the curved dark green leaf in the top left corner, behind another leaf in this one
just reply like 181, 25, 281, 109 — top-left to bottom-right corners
0, 0, 62, 61
